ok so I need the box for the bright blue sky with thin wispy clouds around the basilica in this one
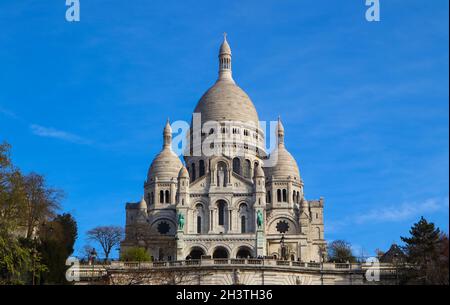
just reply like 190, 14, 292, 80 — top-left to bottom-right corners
0, 0, 449, 255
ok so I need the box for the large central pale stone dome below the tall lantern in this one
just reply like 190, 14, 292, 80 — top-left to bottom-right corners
194, 79, 259, 126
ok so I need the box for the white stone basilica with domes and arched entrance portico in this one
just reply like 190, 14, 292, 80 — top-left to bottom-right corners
121, 36, 326, 262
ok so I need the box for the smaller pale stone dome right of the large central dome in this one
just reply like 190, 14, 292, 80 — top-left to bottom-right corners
264, 146, 300, 180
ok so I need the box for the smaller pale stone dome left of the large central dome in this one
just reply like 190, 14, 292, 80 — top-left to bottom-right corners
147, 147, 183, 182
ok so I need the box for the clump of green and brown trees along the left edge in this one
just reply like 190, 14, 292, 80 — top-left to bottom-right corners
0, 143, 77, 284
